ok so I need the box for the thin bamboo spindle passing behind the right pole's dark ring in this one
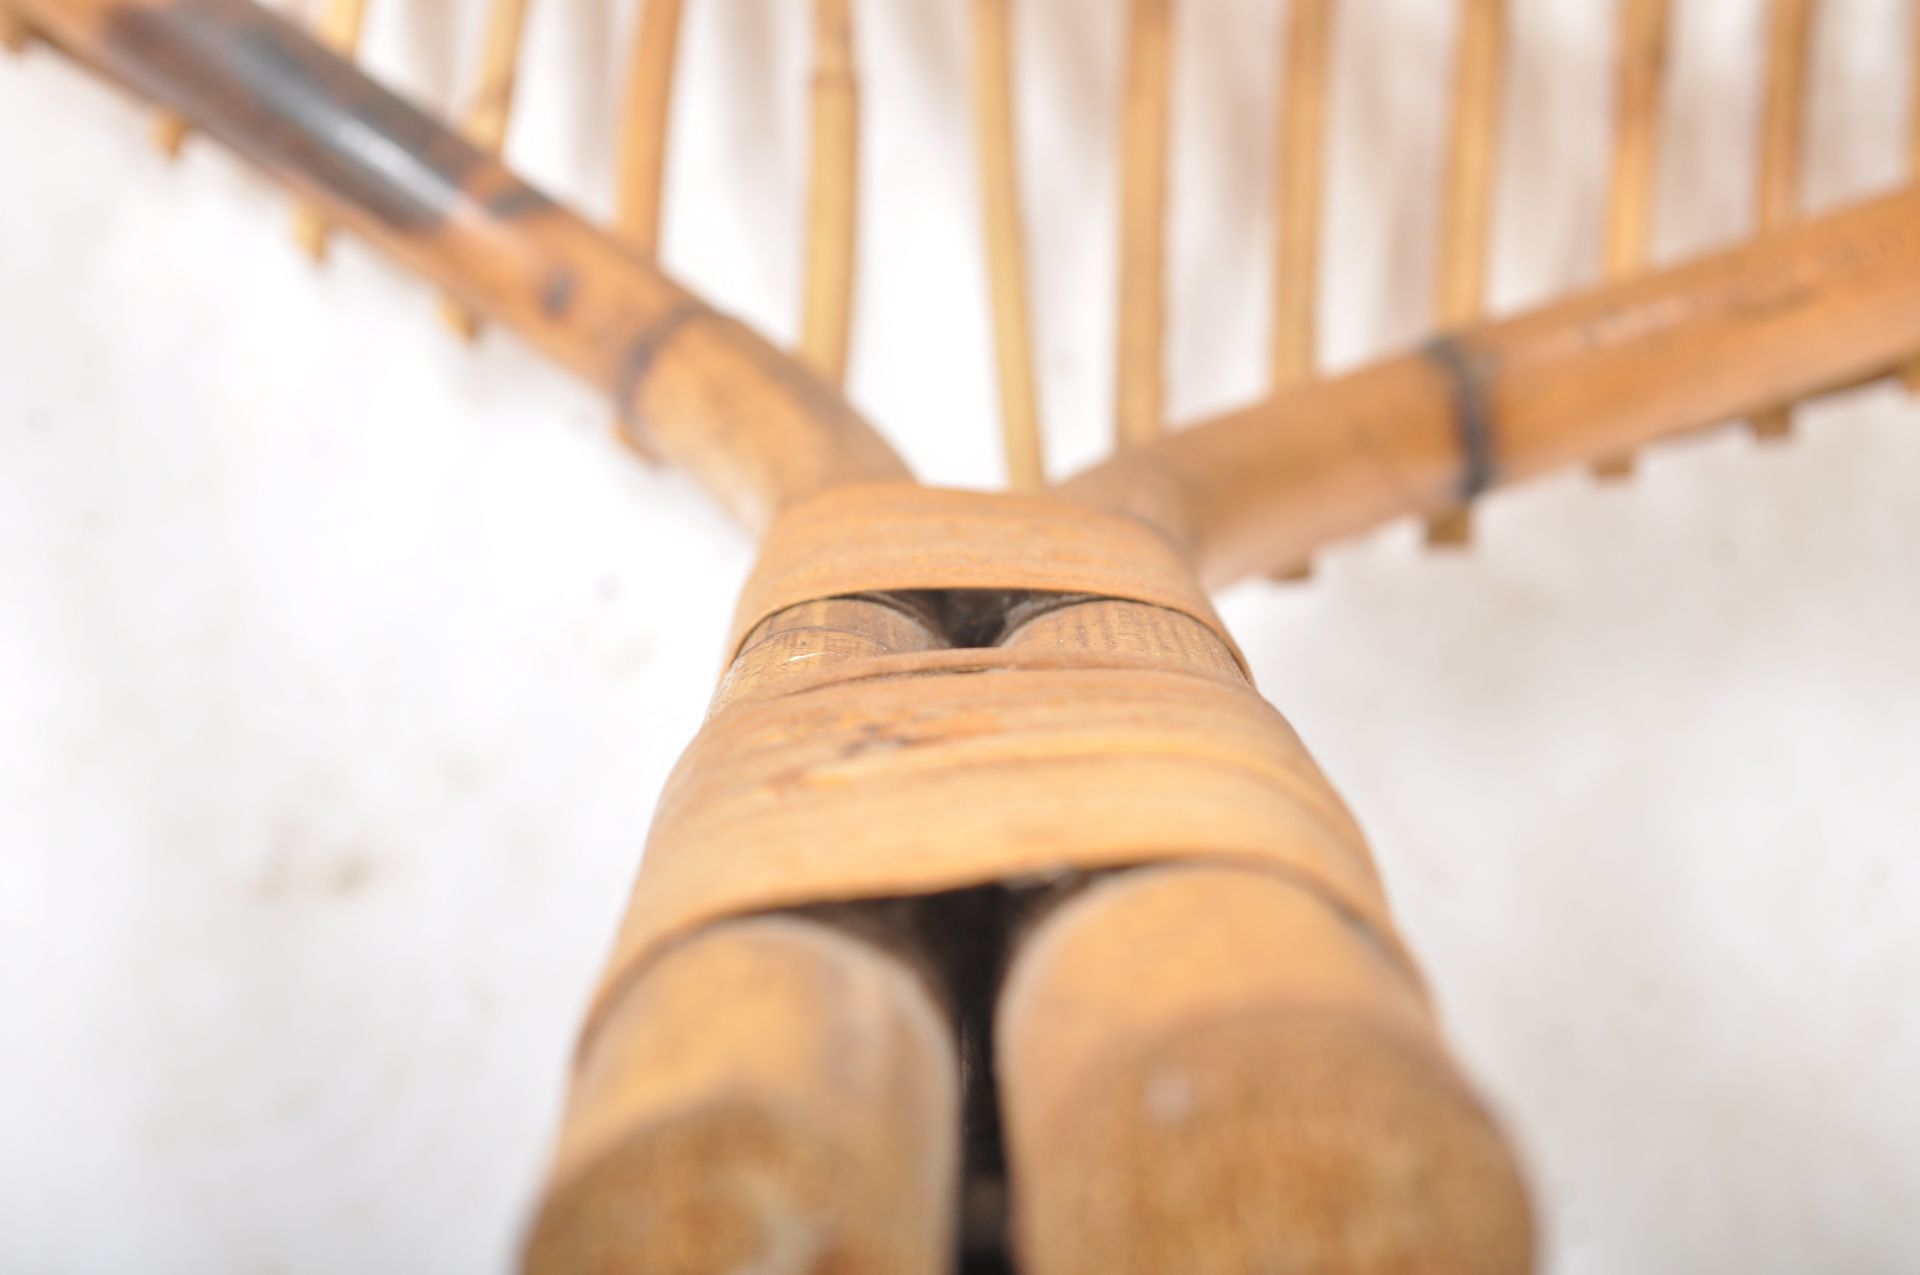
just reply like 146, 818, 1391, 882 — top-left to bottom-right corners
1427, 0, 1507, 545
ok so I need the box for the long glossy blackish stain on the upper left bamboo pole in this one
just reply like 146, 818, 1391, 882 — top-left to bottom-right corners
102, 0, 487, 234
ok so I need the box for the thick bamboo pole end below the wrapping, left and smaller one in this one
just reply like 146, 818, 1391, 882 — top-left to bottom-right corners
524, 916, 960, 1275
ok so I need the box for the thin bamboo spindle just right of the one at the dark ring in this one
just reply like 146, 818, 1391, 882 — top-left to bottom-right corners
1594, 0, 1667, 480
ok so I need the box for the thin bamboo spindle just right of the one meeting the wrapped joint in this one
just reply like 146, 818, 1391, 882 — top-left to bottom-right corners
1114, 0, 1173, 447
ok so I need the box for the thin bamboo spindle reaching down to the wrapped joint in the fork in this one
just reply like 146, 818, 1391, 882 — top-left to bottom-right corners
973, 0, 1046, 492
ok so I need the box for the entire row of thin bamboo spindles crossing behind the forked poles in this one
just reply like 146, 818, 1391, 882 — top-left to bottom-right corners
0, 0, 1920, 543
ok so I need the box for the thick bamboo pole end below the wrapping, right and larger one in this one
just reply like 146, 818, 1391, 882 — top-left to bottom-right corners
996, 868, 1532, 1275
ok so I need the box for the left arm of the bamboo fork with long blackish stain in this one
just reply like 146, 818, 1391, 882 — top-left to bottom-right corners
19, 0, 908, 528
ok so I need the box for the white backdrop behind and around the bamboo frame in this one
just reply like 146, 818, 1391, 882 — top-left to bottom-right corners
0, 0, 1920, 1275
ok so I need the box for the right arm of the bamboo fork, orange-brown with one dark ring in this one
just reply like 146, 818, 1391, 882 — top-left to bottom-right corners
1062, 186, 1920, 586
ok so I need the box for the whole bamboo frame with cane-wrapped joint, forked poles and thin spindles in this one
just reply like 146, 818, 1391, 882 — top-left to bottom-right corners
0, 0, 1920, 1275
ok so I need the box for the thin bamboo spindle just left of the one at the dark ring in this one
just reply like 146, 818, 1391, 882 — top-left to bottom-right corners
1267, 0, 1332, 582
